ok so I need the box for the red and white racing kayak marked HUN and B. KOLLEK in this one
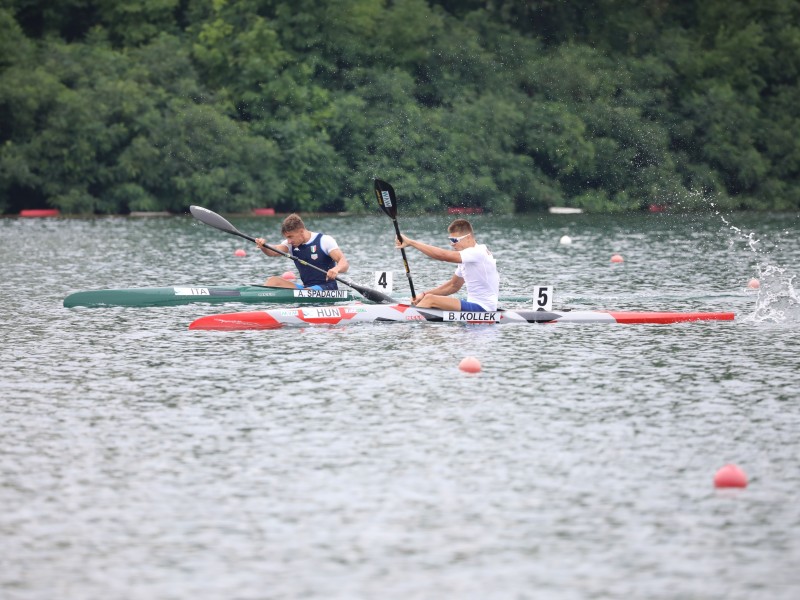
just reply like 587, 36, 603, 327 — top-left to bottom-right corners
189, 304, 734, 331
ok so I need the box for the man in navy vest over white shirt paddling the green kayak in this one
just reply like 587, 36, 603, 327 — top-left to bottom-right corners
256, 214, 350, 290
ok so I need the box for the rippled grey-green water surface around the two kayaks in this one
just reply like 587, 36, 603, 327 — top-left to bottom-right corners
0, 209, 800, 600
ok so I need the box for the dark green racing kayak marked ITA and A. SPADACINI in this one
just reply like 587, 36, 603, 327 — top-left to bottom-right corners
64, 285, 362, 308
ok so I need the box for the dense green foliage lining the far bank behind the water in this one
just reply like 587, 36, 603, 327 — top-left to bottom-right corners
0, 0, 800, 214
